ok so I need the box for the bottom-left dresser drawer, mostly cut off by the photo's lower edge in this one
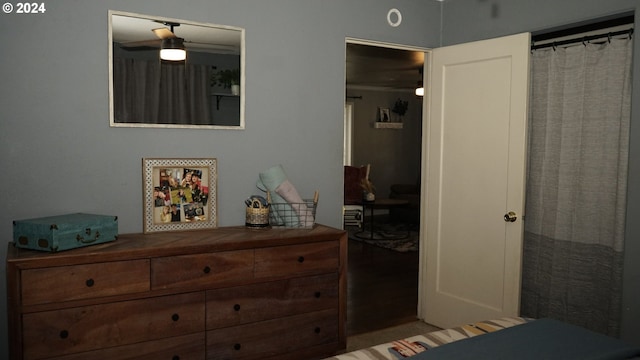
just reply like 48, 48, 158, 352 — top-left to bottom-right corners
49, 332, 205, 360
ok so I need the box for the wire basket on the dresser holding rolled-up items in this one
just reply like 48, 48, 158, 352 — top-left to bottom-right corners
269, 191, 318, 229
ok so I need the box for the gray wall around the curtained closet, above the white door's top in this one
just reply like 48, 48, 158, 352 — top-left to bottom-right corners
442, 0, 640, 345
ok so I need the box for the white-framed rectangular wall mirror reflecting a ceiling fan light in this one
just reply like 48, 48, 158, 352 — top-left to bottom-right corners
109, 10, 245, 129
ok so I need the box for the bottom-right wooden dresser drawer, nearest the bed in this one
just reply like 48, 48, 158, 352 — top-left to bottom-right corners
207, 309, 338, 360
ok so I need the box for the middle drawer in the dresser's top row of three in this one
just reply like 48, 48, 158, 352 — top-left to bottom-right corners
151, 250, 253, 290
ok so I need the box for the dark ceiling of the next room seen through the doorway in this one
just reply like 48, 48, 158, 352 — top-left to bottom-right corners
346, 43, 424, 90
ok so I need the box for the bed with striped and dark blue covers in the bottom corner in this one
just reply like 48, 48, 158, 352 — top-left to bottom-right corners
325, 317, 640, 360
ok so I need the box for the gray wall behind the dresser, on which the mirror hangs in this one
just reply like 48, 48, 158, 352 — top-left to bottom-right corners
0, 0, 440, 358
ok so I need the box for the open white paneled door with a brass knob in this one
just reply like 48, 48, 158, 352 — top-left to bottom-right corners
419, 33, 530, 328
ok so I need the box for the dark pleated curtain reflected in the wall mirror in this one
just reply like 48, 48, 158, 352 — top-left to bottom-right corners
113, 58, 211, 125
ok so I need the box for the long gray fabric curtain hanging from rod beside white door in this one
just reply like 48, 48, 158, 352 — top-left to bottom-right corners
522, 39, 632, 336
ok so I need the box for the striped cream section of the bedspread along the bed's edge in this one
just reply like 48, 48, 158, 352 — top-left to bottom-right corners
325, 317, 528, 360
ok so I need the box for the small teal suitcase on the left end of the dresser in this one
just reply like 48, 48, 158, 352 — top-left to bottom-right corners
13, 213, 118, 252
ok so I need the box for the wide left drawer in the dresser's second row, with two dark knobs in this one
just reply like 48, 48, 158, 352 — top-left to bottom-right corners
22, 292, 205, 359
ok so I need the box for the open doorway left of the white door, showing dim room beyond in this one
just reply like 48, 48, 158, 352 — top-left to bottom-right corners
343, 39, 426, 336
